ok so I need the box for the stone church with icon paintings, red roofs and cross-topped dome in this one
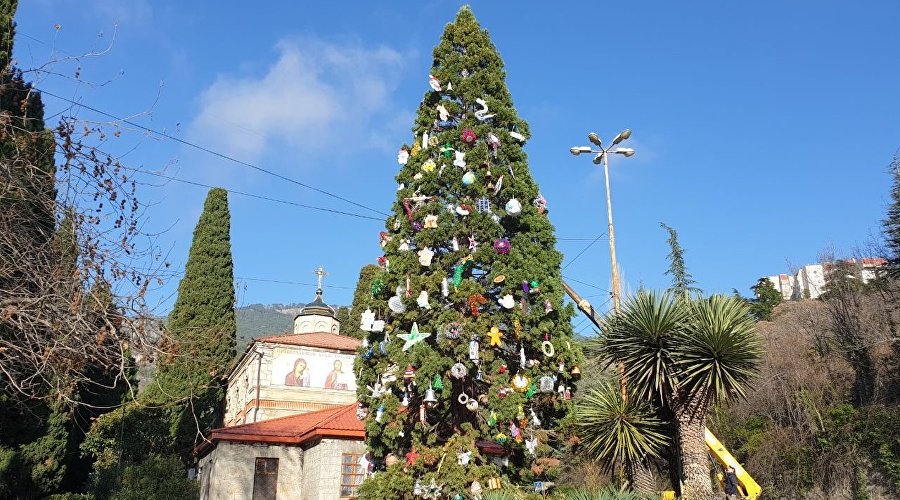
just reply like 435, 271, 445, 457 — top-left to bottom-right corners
197, 268, 368, 500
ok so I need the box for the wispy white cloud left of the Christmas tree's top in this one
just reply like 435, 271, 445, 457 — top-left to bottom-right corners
190, 39, 403, 160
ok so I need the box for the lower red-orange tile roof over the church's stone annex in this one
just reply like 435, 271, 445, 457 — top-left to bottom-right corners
210, 403, 366, 446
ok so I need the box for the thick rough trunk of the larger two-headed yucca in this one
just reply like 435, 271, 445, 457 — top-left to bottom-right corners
675, 398, 715, 500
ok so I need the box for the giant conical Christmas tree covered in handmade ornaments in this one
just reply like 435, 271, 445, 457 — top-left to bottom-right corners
356, 7, 582, 498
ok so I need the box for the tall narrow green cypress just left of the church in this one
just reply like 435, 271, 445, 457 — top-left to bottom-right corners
145, 188, 237, 453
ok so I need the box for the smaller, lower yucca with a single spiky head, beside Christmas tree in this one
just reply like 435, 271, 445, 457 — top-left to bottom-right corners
577, 382, 668, 492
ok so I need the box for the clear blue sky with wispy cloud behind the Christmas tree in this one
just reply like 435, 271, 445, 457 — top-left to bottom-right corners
16, 0, 900, 330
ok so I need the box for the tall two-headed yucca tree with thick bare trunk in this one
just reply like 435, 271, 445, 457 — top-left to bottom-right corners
596, 291, 762, 500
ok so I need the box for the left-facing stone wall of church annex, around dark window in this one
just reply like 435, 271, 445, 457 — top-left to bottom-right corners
199, 441, 304, 500
